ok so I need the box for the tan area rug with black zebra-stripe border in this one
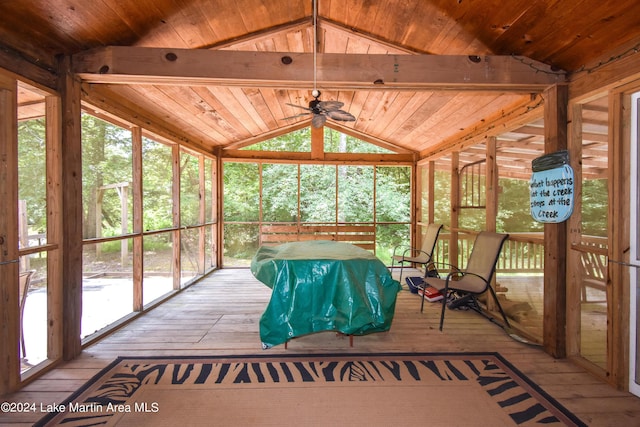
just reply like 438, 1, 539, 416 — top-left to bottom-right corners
36, 353, 585, 427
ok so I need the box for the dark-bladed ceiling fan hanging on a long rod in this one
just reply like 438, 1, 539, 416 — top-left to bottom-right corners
283, 0, 356, 128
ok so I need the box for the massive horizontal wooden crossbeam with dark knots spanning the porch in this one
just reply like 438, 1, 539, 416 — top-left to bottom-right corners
73, 46, 565, 92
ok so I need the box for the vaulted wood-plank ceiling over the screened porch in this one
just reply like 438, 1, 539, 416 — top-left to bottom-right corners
0, 0, 640, 177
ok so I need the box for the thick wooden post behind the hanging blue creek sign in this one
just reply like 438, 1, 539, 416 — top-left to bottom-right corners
543, 85, 568, 358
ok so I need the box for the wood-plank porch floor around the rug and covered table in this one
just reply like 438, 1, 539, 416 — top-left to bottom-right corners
0, 269, 640, 427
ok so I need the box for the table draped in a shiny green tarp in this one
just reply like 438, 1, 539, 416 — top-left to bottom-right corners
251, 240, 401, 349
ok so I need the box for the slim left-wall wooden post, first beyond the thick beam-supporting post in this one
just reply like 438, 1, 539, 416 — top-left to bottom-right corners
132, 126, 144, 311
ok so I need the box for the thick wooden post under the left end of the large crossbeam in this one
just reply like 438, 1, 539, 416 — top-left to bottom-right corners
59, 57, 82, 360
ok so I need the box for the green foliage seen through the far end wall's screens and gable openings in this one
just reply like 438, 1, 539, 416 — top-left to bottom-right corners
223, 128, 411, 264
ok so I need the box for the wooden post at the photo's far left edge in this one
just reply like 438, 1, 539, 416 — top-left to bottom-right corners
0, 74, 20, 396
